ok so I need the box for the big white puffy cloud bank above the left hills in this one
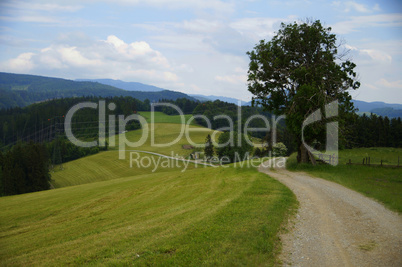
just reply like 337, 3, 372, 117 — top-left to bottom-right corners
0, 35, 180, 84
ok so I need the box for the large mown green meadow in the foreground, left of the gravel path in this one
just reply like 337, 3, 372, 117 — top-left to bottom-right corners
0, 166, 297, 266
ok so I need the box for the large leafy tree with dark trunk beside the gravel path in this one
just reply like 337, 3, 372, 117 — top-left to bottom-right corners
247, 20, 360, 162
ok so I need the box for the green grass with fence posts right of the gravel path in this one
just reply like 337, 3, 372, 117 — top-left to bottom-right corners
286, 148, 402, 213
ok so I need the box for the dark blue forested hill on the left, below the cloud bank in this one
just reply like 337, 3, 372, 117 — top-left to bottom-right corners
0, 72, 196, 108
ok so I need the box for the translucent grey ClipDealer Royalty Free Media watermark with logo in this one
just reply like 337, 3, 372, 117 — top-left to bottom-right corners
64, 100, 338, 172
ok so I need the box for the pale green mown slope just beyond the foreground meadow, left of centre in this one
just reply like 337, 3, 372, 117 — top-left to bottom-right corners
51, 150, 200, 188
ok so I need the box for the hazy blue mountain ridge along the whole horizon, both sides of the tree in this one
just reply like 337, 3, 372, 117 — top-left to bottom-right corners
0, 72, 402, 118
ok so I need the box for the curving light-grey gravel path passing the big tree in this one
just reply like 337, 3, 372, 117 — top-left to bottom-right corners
259, 158, 402, 266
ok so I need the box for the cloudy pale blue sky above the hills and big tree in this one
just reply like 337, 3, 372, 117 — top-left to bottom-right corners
0, 0, 402, 104
